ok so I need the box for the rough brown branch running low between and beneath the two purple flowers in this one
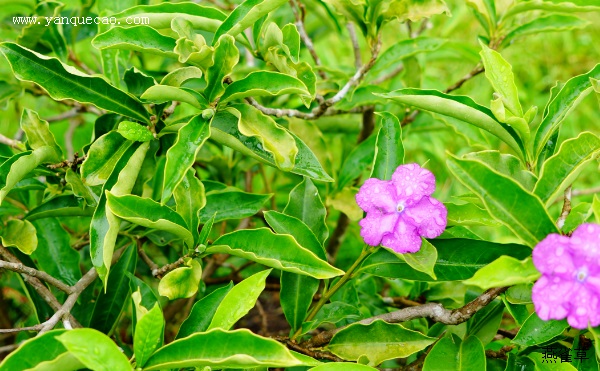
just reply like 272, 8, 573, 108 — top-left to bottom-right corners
300, 287, 508, 348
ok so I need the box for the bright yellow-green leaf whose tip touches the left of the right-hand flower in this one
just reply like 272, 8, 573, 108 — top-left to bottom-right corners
463, 256, 540, 290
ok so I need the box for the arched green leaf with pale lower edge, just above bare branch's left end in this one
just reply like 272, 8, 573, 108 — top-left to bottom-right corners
219, 71, 310, 103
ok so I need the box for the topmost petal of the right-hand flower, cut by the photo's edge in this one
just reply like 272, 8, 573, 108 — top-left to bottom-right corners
571, 223, 600, 273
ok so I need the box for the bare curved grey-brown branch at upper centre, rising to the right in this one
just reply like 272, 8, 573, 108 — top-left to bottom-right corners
246, 38, 381, 120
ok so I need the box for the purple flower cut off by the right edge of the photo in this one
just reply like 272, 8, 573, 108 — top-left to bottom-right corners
531, 224, 600, 329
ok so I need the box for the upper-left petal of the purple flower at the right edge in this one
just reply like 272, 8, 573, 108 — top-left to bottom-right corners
533, 233, 576, 278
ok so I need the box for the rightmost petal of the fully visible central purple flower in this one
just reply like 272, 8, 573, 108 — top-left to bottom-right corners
403, 196, 448, 238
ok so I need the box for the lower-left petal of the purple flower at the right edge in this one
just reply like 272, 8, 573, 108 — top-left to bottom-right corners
531, 275, 575, 321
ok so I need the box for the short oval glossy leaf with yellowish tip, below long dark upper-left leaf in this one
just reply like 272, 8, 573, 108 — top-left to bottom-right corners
81, 131, 132, 186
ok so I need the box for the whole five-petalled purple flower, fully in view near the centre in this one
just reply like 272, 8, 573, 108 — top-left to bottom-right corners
356, 164, 448, 254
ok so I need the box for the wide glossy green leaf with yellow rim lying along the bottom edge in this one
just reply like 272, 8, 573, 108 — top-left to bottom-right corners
144, 329, 304, 371
